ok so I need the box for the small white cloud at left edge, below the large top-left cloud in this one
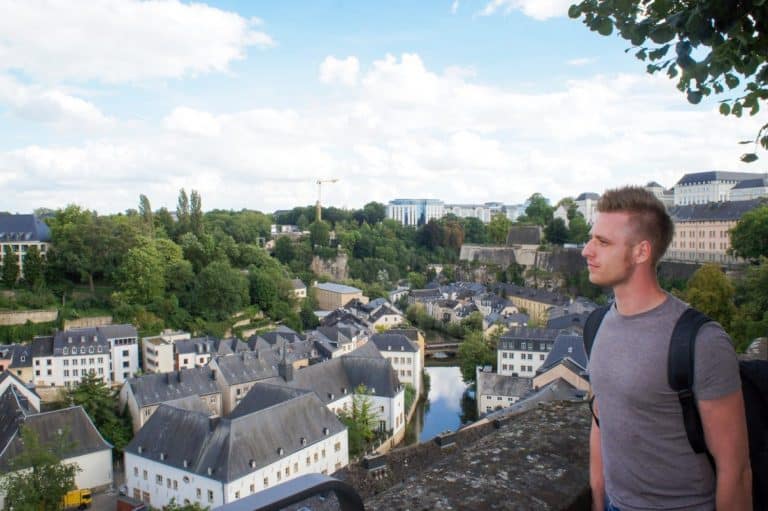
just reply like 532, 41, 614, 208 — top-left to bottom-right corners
0, 74, 114, 128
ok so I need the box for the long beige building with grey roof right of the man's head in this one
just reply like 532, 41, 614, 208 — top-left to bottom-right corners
664, 199, 768, 264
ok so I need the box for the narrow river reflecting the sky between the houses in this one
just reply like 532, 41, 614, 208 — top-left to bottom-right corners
404, 365, 476, 445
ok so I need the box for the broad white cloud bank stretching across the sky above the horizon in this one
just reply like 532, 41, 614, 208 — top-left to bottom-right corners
0, 54, 764, 216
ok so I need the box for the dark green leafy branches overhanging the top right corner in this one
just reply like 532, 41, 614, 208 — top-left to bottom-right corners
568, 0, 768, 162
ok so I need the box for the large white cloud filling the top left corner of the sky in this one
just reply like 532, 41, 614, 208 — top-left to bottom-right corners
0, 0, 274, 83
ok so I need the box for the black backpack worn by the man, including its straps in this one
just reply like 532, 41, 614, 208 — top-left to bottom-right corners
584, 305, 768, 510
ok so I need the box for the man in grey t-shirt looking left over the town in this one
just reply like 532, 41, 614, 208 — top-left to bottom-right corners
582, 187, 751, 511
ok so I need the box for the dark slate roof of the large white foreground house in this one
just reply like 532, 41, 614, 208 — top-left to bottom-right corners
125, 385, 345, 483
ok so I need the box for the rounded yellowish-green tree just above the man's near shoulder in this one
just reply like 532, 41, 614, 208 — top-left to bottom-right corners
684, 264, 736, 330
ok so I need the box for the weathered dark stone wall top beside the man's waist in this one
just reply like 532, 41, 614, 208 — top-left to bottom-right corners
335, 402, 591, 511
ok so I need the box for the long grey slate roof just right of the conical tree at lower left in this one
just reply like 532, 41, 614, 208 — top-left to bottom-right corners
125, 367, 220, 408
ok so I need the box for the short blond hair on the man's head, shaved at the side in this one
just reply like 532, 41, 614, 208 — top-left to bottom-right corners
597, 186, 675, 267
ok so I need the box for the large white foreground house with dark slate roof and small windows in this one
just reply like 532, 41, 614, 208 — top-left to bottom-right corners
124, 383, 349, 508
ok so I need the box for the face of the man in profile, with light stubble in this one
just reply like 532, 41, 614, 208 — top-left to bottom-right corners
581, 212, 635, 287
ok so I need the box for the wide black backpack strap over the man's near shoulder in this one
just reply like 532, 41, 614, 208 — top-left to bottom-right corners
667, 307, 711, 453
